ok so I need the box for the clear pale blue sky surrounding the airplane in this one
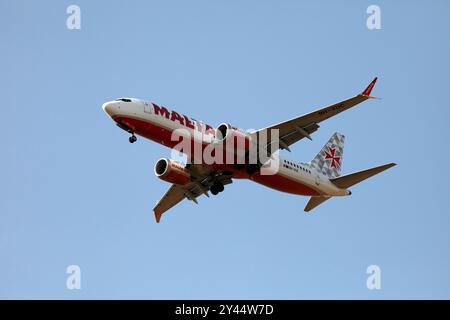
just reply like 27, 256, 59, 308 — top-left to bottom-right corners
0, 0, 450, 299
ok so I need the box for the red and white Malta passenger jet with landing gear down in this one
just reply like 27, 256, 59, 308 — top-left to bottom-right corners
102, 77, 396, 223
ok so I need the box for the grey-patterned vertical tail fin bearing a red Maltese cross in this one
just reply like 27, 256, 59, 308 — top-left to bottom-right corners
310, 132, 345, 179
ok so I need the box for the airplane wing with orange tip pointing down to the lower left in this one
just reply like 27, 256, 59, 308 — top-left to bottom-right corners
153, 170, 233, 223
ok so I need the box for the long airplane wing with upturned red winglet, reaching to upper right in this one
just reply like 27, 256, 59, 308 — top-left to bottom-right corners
252, 78, 377, 154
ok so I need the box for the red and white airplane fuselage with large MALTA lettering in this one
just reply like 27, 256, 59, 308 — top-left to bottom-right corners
103, 98, 350, 196
